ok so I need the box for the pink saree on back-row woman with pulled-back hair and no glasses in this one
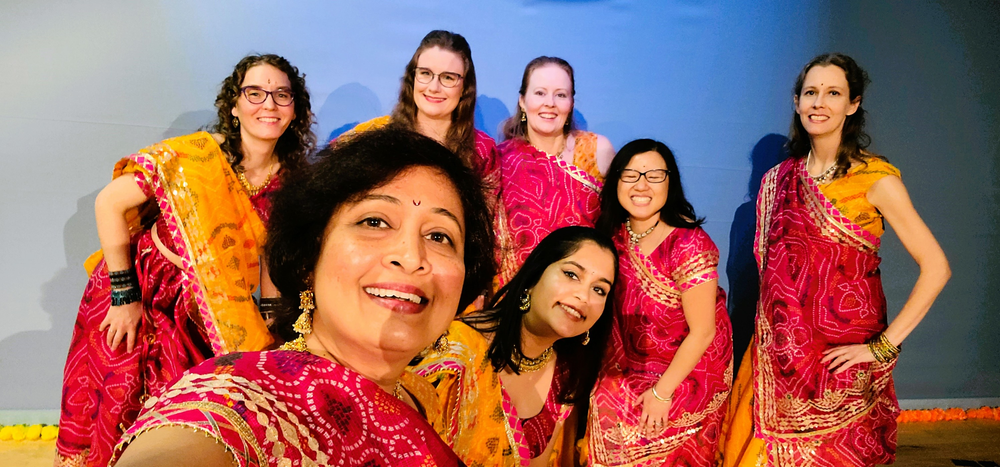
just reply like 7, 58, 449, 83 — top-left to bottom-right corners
494, 133, 602, 286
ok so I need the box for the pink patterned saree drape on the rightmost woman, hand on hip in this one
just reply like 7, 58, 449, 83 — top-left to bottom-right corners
753, 159, 899, 467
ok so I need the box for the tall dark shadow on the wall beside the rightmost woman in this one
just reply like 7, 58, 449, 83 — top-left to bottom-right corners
726, 133, 788, 376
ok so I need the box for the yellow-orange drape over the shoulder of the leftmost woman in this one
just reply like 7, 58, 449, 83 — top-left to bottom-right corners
114, 132, 272, 355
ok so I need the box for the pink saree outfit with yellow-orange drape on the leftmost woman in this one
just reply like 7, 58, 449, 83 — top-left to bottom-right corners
55, 133, 280, 467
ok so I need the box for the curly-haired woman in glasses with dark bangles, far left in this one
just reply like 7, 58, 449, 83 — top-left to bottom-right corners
56, 55, 315, 466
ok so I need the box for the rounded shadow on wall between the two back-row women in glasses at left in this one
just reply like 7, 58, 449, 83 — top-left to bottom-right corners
316, 83, 382, 143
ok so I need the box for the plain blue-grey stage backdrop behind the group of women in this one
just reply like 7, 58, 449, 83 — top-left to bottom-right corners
0, 0, 1000, 416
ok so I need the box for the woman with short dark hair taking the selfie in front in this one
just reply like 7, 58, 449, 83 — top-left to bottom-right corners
116, 129, 494, 467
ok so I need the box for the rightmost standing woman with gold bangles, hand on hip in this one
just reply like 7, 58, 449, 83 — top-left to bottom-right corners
723, 53, 951, 467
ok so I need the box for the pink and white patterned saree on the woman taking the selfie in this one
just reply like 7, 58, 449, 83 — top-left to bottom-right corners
112, 350, 459, 467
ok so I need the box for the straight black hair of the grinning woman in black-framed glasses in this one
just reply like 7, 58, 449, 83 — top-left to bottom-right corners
597, 139, 705, 235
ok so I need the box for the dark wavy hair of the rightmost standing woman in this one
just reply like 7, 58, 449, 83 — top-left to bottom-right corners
788, 53, 886, 178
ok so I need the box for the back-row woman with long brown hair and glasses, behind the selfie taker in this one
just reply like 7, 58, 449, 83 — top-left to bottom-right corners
335, 30, 497, 184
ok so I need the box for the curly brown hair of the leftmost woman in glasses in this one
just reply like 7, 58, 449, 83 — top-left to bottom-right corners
212, 54, 316, 174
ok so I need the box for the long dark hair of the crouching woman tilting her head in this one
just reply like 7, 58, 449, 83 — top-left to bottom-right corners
462, 226, 618, 404
